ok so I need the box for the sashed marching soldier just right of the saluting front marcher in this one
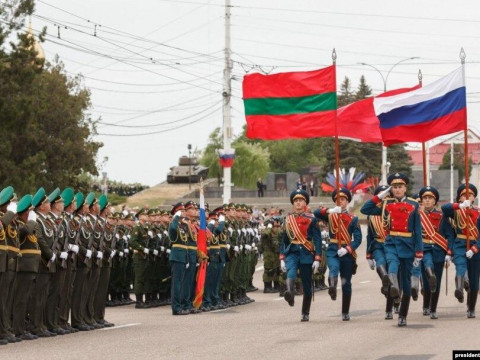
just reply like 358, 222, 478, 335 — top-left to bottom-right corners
414, 186, 454, 319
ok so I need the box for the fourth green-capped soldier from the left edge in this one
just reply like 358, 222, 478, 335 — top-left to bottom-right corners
45, 188, 70, 335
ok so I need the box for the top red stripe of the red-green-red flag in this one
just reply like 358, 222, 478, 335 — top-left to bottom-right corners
243, 65, 336, 99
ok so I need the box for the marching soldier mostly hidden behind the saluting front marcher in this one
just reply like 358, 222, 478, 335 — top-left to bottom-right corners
367, 185, 394, 320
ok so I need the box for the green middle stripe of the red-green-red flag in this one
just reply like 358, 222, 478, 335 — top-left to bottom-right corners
244, 92, 337, 115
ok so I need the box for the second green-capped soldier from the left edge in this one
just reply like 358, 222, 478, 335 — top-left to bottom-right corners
12, 194, 41, 340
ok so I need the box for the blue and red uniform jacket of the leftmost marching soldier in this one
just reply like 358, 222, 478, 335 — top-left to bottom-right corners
279, 213, 322, 264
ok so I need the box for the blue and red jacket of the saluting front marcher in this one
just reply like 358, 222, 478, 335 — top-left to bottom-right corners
360, 196, 423, 258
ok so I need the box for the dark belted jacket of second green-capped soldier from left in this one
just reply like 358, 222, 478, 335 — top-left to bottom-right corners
16, 219, 41, 273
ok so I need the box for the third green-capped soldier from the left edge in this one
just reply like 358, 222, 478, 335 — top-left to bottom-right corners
28, 188, 57, 337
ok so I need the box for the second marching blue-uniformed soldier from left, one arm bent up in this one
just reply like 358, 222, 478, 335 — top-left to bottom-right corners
314, 188, 362, 321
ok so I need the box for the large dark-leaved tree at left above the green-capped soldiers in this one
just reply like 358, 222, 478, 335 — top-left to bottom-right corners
0, 5, 102, 194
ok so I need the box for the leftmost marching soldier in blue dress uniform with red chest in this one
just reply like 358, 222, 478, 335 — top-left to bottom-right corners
279, 190, 322, 321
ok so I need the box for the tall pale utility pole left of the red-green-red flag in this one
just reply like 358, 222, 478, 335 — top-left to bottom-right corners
222, 0, 232, 203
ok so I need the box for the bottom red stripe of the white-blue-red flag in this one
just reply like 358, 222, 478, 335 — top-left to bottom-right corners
381, 108, 467, 146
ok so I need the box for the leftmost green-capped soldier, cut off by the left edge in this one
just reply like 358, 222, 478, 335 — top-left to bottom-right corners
0, 186, 19, 345
